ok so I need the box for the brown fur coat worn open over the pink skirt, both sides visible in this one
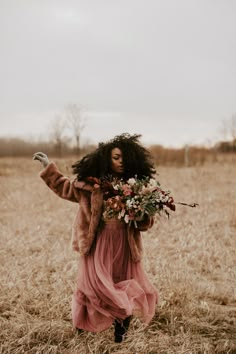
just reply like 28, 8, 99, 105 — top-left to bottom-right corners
40, 162, 153, 262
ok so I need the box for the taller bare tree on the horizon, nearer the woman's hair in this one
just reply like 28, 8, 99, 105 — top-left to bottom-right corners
65, 104, 85, 155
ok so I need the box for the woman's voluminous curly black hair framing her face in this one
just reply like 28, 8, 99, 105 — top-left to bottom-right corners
72, 133, 156, 181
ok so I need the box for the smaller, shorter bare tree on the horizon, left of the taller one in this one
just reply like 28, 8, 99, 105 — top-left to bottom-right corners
51, 115, 66, 157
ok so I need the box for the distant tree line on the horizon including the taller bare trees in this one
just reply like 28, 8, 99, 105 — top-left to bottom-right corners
0, 110, 236, 166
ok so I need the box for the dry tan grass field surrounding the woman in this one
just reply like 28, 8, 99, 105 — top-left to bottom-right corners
0, 157, 236, 354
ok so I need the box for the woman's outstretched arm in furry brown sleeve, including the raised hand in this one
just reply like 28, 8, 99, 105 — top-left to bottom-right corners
33, 153, 80, 203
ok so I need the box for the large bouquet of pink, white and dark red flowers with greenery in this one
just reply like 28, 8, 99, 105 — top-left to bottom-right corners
88, 177, 179, 227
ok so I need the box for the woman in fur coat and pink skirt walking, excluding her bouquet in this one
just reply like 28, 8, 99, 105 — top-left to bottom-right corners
33, 134, 157, 342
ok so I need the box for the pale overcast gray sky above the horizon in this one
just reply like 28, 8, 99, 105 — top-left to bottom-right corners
0, 0, 236, 146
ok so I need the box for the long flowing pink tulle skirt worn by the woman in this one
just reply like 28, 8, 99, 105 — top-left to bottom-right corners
72, 220, 157, 332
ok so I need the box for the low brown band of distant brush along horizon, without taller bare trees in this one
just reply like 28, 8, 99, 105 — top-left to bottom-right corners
0, 138, 233, 166
